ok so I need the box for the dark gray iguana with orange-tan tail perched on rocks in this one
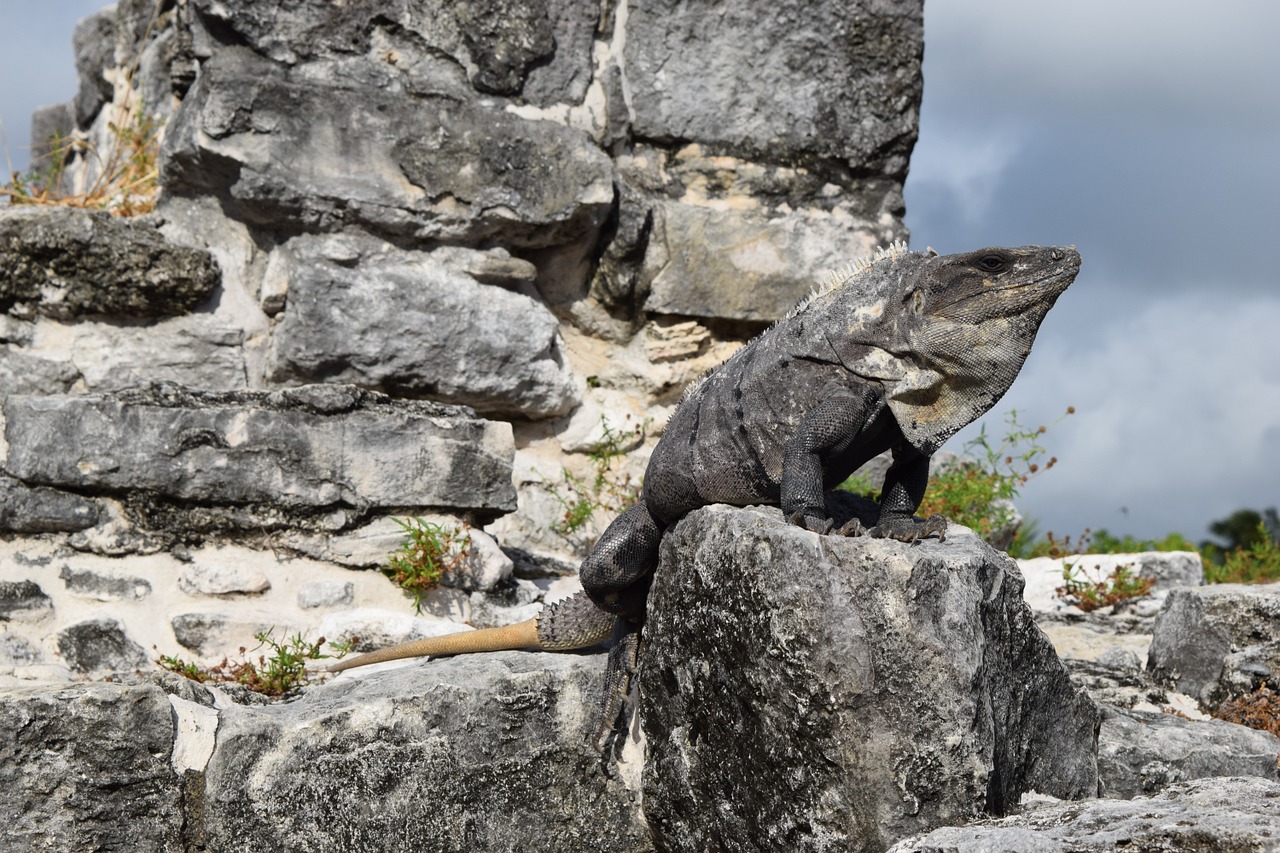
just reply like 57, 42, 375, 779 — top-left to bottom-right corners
330, 243, 1080, 744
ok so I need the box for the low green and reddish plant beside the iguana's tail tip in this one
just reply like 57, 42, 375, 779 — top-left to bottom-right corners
156, 628, 356, 697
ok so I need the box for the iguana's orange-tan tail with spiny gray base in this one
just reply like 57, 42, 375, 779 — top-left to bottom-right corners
329, 593, 613, 672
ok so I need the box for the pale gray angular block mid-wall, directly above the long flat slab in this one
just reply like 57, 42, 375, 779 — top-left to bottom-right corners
269, 236, 577, 418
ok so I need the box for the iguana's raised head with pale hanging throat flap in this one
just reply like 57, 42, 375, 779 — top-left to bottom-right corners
819, 246, 1080, 453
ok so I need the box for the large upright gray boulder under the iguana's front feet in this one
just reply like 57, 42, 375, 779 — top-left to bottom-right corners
640, 506, 1098, 850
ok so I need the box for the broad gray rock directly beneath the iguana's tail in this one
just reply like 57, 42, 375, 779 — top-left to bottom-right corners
202, 652, 652, 853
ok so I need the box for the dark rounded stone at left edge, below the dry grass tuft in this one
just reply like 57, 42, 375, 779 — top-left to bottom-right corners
0, 205, 220, 320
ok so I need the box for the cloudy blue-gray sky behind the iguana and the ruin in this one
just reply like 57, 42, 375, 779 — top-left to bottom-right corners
0, 0, 1280, 538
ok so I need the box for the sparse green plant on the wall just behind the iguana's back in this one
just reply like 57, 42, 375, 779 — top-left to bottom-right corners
545, 415, 649, 552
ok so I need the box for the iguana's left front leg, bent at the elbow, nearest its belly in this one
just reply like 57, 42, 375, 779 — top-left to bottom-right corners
780, 389, 884, 533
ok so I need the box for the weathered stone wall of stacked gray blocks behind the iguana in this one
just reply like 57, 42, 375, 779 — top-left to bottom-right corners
0, 0, 923, 679
